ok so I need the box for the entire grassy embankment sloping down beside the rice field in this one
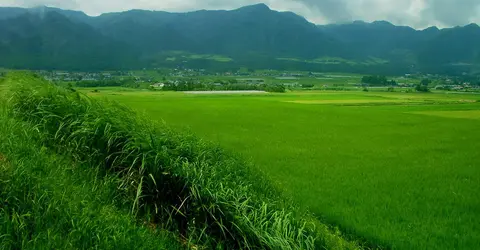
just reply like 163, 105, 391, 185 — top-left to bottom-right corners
0, 73, 357, 249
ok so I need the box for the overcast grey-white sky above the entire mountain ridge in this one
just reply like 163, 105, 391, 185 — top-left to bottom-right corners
0, 0, 480, 28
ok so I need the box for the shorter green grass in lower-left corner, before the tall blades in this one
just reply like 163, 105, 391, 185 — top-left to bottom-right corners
0, 102, 181, 249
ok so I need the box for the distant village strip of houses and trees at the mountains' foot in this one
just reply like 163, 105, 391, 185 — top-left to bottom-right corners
36, 68, 480, 92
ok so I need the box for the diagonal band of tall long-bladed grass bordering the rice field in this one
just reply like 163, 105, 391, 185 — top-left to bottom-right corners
3, 74, 356, 249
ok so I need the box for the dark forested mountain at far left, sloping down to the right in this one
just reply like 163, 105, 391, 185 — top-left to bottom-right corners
0, 11, 135, 69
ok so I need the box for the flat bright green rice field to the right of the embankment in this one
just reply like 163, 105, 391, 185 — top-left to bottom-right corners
88, 89, 480, 249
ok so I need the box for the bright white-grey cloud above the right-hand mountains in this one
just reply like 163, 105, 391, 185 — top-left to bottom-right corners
297, 0, 480, 28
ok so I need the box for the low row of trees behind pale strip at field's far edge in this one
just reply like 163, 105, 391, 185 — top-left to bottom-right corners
162, 81, 286, 93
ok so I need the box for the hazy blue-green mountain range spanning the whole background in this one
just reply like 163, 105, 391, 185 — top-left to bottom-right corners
0, 4, 480, 74
